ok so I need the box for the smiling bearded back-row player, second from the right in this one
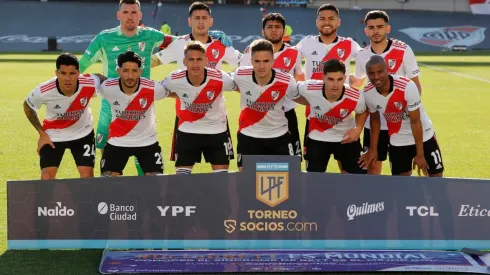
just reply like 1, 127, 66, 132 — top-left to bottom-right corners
296, 4, 361, 171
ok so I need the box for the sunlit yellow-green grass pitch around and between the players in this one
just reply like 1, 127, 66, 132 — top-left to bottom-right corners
0, 53, 490, 275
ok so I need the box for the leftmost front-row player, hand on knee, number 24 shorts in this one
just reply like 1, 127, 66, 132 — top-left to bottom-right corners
24, 53, 106, 179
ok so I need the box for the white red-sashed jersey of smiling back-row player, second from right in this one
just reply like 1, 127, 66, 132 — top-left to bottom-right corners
296, 35, 361, 117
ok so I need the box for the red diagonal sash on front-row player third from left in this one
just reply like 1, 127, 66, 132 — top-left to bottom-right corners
179, 79, 223, 126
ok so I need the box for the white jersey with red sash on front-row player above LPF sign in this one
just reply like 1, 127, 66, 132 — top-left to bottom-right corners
233, 67, 298, 138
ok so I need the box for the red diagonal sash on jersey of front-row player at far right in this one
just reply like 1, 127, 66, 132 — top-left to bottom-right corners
384, 89, 407, 137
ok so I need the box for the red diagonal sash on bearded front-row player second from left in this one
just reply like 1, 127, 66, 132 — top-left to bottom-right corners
109, 88, 155, 139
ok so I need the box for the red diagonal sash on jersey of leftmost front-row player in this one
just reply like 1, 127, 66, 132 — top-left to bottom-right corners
43, 86, 95, 130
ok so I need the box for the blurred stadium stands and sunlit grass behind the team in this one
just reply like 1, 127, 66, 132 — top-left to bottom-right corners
0, 0, 490, 275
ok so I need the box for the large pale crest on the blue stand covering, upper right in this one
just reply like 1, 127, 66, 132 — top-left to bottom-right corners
400, 26, 486, 48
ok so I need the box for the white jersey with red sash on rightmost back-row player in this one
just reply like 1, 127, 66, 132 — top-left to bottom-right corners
355, 39, 420, 130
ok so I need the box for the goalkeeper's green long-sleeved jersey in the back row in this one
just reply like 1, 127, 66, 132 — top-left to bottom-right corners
80, 27, 173, 78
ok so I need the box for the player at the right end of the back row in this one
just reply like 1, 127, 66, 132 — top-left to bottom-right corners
353, 10, 422, 175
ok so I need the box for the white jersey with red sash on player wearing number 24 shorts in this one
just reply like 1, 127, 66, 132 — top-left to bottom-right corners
26, 74, 100, 142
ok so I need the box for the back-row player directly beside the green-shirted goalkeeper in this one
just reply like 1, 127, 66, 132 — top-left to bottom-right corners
152, 2, 242, 162
